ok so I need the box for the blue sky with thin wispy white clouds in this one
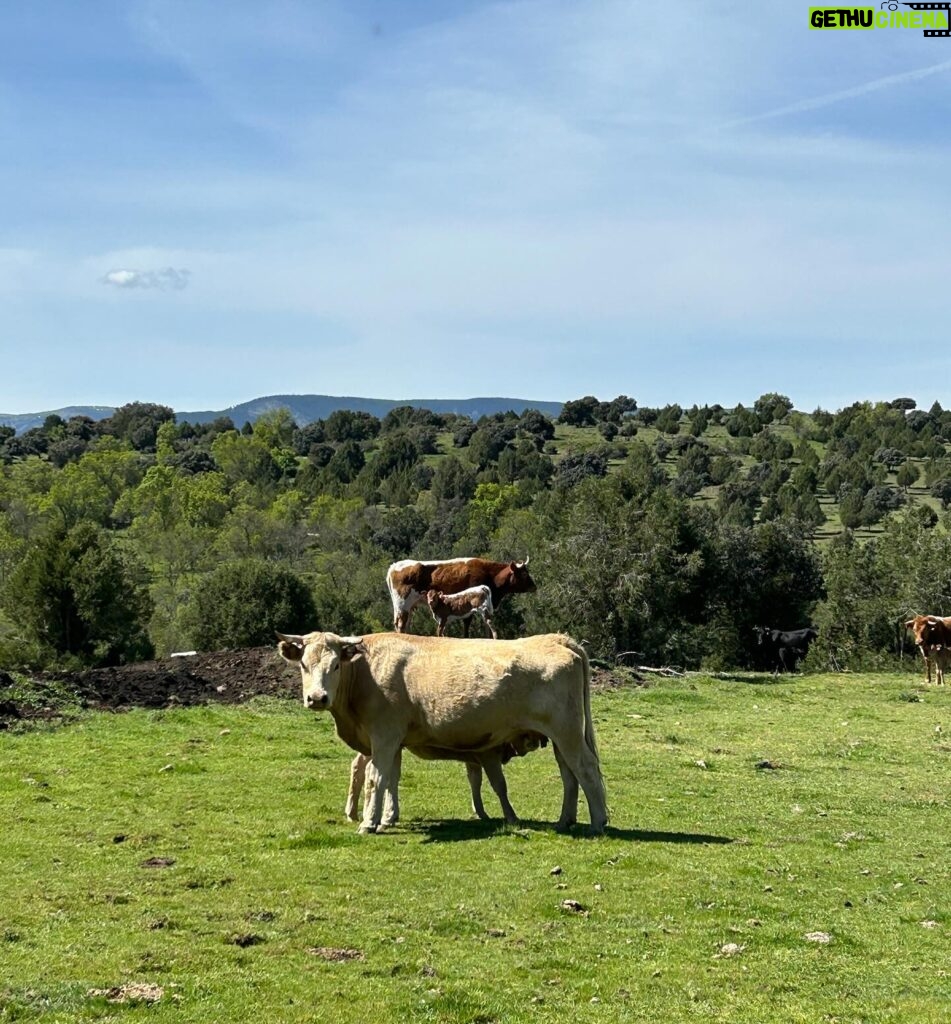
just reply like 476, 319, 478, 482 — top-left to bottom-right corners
0, 0, 951, 413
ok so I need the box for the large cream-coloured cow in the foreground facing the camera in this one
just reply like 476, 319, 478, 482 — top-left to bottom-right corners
277, 633, 607, 833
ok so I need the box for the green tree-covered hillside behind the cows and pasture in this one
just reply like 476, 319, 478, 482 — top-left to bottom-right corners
0, 394, 951, 671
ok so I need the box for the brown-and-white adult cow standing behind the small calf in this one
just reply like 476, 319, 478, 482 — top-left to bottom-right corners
386, 558, 535, 633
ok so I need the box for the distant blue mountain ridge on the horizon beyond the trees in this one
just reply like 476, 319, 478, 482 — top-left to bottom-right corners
0, 394, 563, 434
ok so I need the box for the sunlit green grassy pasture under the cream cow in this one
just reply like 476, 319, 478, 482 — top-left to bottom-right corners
0, 675, 951, 1024
